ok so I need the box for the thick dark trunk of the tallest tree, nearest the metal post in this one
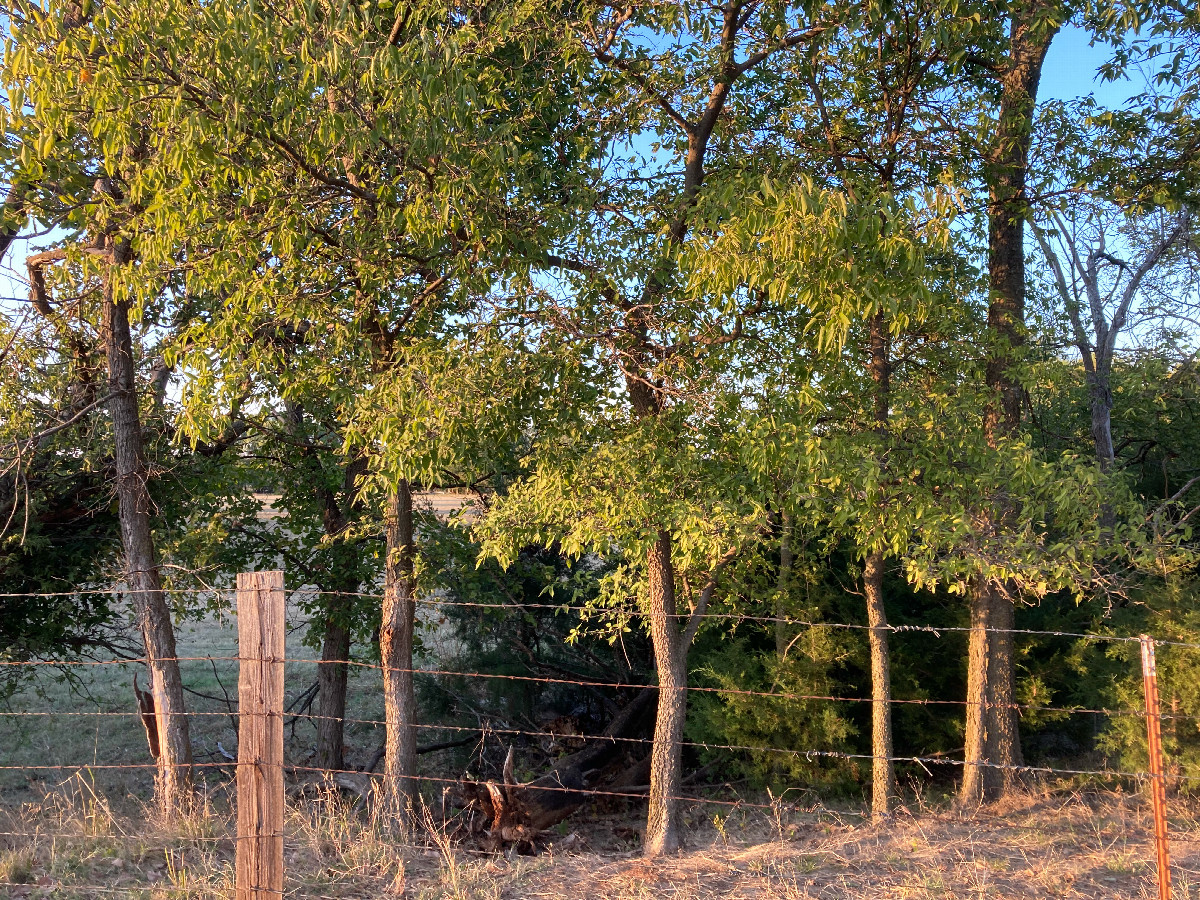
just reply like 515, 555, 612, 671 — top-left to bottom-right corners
960, 0, 1064, 804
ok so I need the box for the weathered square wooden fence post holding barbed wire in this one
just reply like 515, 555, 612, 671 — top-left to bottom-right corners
235, 571, 284, 900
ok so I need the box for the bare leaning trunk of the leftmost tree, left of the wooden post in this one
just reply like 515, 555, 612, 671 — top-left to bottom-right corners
103, 247, 192, 816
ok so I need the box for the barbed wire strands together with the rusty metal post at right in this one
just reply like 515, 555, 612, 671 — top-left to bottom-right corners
0, 574, 1185, 900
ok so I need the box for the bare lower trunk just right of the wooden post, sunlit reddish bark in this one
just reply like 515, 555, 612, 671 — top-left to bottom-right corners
379, 481, 418, 823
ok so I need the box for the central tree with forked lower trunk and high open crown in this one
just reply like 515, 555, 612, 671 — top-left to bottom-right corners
487, 0, 864, 857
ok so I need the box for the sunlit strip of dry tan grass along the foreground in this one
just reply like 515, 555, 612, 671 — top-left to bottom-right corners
0, 776, 1200, 900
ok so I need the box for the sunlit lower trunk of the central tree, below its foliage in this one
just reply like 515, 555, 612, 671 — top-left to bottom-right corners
646, 532, 688, 857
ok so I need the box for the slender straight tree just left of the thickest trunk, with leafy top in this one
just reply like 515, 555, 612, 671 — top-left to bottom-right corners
748, 0, 977, 818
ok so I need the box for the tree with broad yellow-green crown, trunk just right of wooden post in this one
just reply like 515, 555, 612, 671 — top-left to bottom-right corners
68, 2, 592, 808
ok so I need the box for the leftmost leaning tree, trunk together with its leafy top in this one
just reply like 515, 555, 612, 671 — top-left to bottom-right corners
2, 5, 201, 814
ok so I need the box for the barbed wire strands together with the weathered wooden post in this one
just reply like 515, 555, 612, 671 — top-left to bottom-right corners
0, 572, 1180, 896
